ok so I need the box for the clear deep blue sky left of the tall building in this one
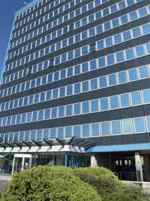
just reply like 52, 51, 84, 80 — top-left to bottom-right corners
0, 0, 32, 72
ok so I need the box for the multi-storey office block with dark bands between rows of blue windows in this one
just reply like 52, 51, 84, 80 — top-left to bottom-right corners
0, 0, 150, 180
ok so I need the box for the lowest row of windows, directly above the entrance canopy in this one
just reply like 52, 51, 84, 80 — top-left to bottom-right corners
0, 116, 150, 143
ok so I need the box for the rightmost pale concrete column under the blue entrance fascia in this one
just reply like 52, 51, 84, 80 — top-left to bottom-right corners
135, 152, 143, 181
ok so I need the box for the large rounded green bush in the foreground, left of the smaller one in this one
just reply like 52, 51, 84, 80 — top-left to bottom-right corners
2, 166, 101, 201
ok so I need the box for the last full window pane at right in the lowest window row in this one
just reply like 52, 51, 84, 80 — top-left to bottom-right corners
134, 117, 146, 133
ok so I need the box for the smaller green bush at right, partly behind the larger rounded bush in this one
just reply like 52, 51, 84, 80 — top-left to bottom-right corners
74, 168, 147, 201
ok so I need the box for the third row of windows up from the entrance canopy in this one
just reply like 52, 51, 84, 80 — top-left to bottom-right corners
0, 65, 150, 111
